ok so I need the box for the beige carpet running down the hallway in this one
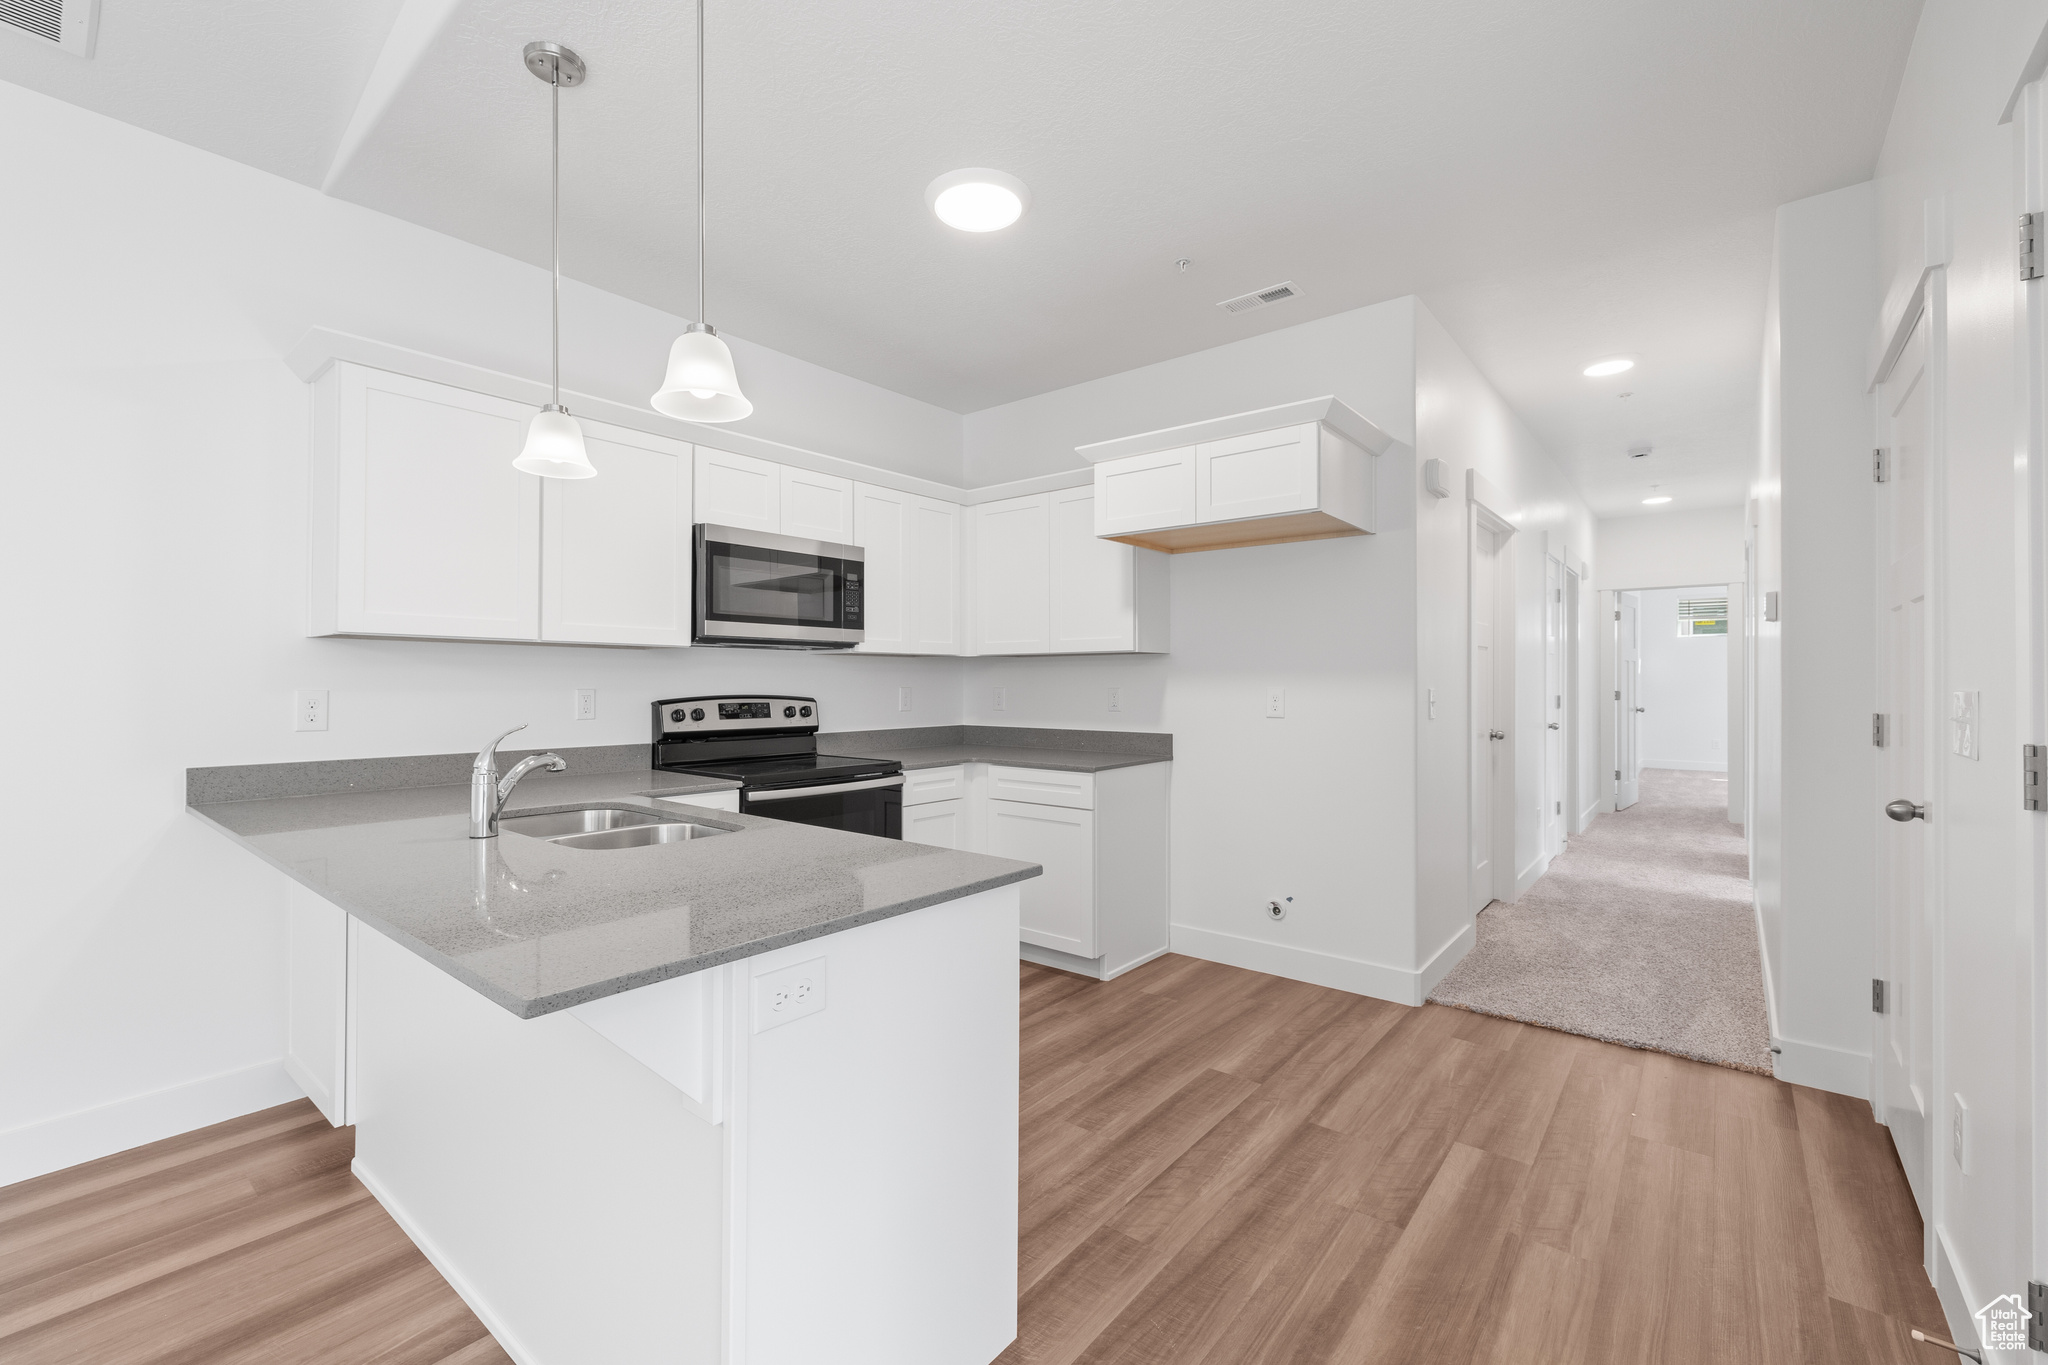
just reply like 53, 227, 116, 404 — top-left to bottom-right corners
1430, 767, 1772, 1074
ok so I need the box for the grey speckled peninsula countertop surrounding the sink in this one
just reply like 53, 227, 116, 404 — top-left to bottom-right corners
188, 765, 1038, 1019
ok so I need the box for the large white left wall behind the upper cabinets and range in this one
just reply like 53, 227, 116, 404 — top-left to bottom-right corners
0, 84, 961, 1183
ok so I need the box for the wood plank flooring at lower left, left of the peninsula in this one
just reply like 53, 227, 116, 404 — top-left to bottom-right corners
0, 1099, 512, 1365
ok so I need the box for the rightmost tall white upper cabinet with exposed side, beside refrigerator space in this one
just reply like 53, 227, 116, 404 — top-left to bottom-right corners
1051, 483, 1169, 655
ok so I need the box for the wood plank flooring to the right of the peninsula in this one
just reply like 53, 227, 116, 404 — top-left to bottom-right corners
1001, 956, 1954, 1365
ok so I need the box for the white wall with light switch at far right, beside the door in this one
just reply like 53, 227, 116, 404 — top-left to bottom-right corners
1875, 0, 2048, 1361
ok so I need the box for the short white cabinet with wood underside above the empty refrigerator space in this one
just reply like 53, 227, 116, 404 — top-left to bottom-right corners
1077, 397, 1395, 555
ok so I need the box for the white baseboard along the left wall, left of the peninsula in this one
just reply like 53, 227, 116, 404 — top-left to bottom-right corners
0, 1060, 303, 1185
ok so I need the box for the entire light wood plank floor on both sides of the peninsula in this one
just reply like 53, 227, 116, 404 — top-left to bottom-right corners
0, 958, 1954, 1365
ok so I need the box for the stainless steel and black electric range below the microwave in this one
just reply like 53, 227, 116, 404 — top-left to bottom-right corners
653, 696, 903, 839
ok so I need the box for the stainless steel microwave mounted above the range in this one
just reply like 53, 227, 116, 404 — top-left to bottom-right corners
690, 522, 866, 649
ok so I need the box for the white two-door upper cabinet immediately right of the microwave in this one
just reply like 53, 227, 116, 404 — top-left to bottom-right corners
854, 483, 961, 655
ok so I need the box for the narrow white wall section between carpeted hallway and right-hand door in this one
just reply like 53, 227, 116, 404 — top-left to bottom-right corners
1755, 184, 1878, 1097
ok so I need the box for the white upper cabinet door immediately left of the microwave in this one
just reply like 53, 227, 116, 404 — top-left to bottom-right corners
541, 422, 692, 645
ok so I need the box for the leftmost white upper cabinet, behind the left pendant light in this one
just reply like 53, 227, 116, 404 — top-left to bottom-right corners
307, 362, 541, 641
